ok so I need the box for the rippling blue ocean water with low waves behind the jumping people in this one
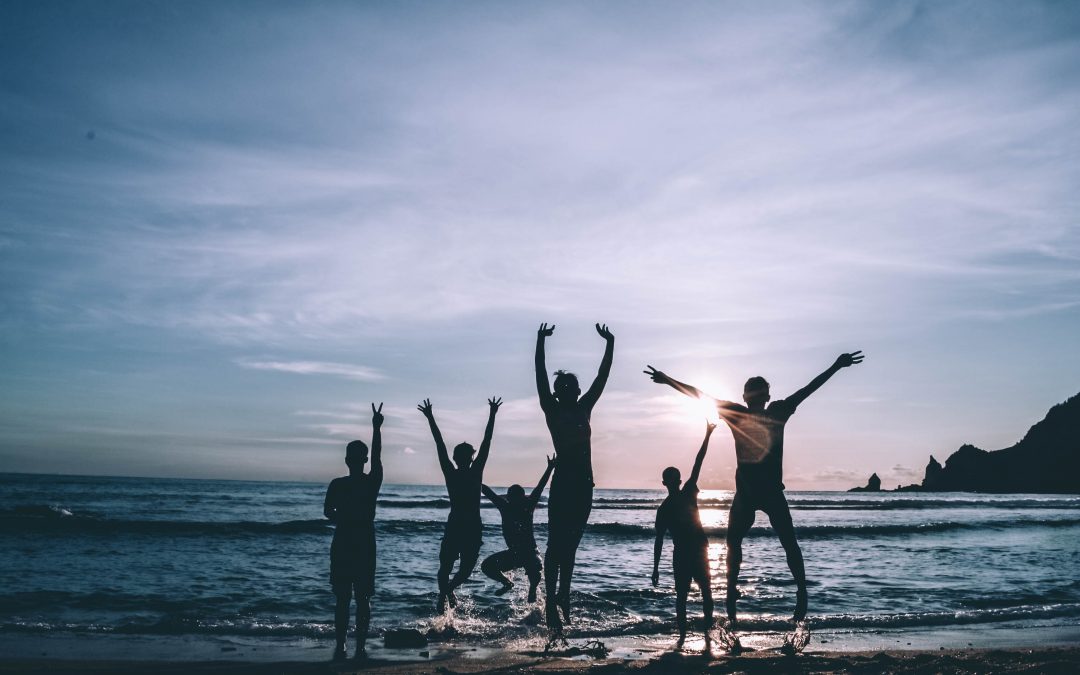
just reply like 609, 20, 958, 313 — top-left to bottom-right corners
0, 474, 1080, 646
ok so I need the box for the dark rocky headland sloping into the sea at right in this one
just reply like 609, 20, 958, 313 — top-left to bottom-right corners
849, 394, 1080, 494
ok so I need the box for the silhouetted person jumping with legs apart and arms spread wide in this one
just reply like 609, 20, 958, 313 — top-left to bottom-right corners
645, 351, 863, 627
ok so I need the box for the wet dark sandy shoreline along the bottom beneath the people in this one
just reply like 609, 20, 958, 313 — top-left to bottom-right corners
0, 624, 1080, 675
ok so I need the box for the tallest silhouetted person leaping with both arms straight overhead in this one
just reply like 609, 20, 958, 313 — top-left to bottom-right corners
536, 324, 615, 633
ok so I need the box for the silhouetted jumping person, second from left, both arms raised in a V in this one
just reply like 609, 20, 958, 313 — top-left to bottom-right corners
417, 399, 502, 612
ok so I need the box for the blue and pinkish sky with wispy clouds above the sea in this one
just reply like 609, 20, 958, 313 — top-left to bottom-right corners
0, 0, 1080, 489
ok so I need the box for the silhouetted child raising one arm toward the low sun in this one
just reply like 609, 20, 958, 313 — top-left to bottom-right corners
652, 422, 716, 648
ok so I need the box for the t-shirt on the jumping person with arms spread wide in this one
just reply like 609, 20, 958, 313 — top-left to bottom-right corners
716, 400, 795, 490
